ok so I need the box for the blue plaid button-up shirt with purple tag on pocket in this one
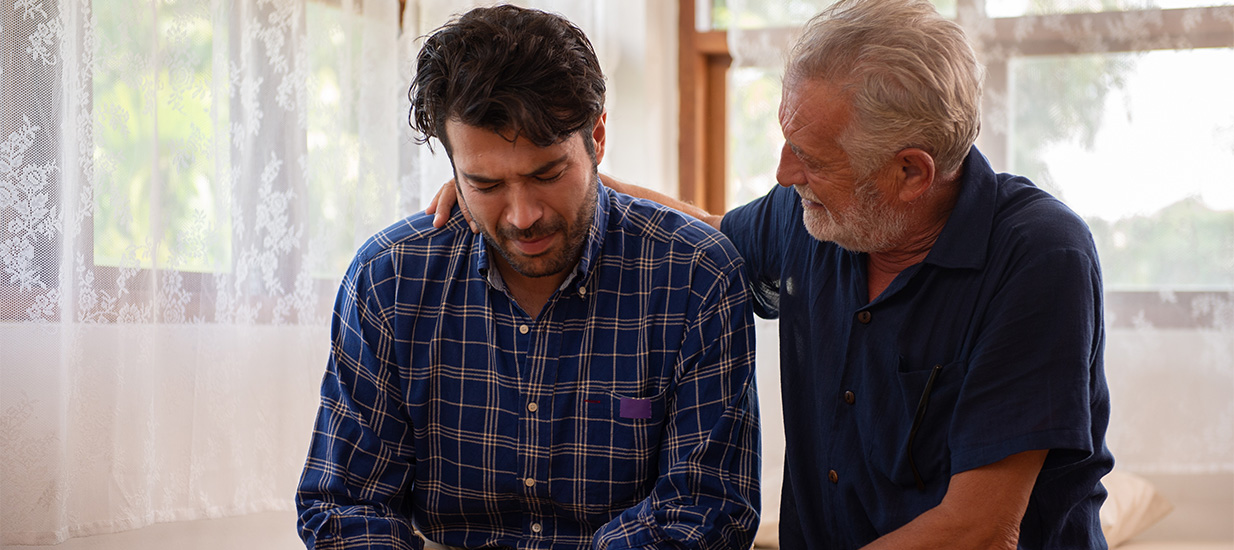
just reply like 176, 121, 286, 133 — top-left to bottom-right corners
296, 186, 759, 549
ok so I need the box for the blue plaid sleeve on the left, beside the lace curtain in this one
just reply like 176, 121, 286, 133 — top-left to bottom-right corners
296, 250, 423, 550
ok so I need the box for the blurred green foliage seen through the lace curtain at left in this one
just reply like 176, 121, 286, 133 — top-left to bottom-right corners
91, 2, 365, 279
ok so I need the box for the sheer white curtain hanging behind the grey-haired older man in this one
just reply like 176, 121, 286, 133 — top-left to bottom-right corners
708, 0, 1234, 532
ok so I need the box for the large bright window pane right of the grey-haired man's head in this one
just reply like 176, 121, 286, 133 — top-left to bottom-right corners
1008, 48, 1234, 290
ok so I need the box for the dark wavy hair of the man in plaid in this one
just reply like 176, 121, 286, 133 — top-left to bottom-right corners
408, 5, 605, 158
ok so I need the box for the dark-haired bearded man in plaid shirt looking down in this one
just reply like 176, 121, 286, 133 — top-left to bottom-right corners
297, 6, 759, 550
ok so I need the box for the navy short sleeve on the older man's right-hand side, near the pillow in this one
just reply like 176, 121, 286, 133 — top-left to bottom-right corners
949, 199, 1104, 472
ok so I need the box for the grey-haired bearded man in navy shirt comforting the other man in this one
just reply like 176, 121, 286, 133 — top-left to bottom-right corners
431, 0, 1113, 549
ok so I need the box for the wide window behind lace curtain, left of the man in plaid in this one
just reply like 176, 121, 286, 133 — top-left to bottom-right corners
0, 0, 407, 323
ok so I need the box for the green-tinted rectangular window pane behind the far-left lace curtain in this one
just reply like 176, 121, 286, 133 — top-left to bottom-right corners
91, 2, 231, 271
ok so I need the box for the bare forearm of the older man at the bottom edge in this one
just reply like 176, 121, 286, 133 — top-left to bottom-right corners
864, 450, 1049, 550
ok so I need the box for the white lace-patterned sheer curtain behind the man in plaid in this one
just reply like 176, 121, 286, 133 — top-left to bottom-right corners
0, 0, 675, 545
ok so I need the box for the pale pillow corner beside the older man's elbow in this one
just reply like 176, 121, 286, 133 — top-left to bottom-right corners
1101, 471, 1174, 548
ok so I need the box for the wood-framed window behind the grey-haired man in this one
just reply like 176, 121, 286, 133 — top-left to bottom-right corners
681, 0, 1234, 303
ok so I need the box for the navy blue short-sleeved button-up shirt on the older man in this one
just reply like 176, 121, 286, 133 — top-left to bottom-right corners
723, 148, 1113, 549
